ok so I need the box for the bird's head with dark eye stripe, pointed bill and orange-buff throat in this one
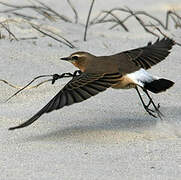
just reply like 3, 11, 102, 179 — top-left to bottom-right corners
60, 52, 95, 72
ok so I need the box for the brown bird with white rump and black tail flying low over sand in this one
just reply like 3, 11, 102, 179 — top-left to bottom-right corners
9, 37, 175, 130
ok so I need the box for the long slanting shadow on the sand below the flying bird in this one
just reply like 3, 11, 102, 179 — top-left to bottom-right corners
24, 118, 157, 142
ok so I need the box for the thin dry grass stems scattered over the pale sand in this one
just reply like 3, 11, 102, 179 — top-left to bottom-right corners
0, 0, 181, 100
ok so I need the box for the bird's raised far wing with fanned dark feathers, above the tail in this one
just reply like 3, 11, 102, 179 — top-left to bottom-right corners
122, 38, 175, 69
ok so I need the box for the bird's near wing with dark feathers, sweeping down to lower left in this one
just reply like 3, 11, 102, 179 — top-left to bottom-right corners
9, 73, 121, 130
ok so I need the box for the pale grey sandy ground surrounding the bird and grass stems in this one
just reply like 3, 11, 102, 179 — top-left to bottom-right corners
0, 0, 181, 180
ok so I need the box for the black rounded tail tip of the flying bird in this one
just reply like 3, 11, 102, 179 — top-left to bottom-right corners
144, 78, 174, 93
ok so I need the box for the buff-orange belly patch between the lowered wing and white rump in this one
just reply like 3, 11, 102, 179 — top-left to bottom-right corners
112, 76, 137, 89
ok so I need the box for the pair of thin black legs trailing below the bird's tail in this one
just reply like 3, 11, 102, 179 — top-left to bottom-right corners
135, 87, 162, 118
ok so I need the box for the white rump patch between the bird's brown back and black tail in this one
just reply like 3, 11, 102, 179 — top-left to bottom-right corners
126, 68, 159, 87
